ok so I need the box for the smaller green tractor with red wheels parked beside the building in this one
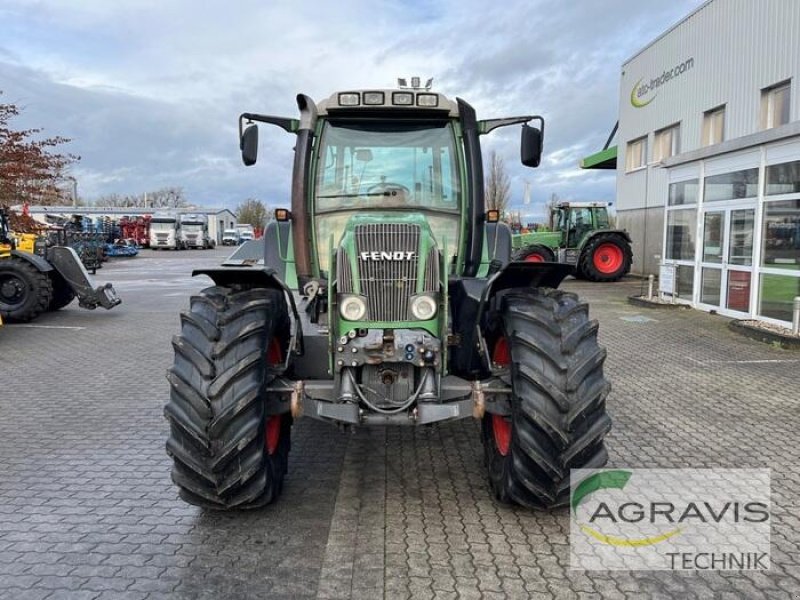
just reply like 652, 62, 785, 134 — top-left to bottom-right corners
512, 202, 633, 281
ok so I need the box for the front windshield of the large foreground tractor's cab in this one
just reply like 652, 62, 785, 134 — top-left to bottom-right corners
313, 121, 462, 270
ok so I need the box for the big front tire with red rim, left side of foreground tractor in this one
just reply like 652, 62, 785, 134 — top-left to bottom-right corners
164, 287, 291, 509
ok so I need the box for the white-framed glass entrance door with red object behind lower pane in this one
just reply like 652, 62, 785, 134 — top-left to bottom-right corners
697, 206, 755, 316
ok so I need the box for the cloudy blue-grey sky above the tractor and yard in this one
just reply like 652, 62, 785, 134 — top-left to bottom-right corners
0, 0, 701, 212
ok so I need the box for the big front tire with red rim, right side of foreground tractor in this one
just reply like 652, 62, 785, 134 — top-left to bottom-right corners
482, 289, 611, 508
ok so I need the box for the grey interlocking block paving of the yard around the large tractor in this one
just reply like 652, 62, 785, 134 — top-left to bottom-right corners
0, 249, 800, 600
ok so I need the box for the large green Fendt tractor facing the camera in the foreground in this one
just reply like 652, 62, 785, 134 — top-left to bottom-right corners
165, 88, 611, 509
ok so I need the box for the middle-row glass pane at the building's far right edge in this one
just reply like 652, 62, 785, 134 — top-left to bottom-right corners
761, 200, 800, 270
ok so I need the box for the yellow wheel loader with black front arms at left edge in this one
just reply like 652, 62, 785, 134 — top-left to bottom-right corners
0, 209, 121, 322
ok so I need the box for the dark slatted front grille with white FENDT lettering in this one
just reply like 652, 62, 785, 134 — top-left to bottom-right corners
355, 223, 420, 321
